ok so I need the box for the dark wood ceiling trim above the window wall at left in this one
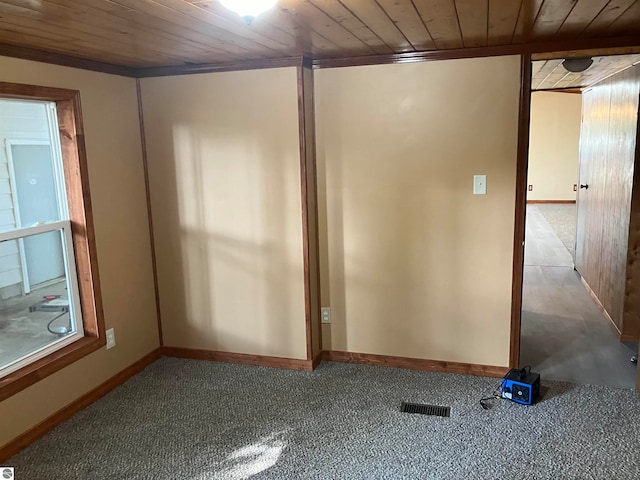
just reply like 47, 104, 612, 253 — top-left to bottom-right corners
0, 43, 136, 77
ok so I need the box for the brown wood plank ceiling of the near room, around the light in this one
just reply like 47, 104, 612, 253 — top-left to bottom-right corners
0, 0, 640, 68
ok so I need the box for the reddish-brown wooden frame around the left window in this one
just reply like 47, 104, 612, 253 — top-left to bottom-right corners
0, 82, 106, 401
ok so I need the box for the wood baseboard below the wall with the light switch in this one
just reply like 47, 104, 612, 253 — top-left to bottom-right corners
322, 350, 509, 378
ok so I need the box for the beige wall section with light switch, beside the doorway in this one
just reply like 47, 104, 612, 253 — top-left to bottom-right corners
316, 57, 520, 366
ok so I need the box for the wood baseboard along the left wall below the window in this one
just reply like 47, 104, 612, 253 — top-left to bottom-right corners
0, 349, 160, 464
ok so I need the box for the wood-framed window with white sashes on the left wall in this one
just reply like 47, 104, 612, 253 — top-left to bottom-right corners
0, 82, 105, 400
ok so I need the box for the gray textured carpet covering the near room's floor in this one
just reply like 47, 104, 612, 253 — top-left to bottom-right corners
7, 359, 640, 480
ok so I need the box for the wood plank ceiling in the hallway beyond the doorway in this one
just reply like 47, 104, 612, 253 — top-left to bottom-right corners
531, 54, 640, 90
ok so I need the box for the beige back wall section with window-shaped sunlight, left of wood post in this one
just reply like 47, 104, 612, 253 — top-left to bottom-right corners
142, 67, 306, 358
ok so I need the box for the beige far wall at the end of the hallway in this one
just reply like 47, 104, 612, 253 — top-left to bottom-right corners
527, 92, 582, 200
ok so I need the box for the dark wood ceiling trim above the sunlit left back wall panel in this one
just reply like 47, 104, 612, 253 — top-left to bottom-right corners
135, 57, 304, 78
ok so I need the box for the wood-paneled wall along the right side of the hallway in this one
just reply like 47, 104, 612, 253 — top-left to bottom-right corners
576, 63, 640, 339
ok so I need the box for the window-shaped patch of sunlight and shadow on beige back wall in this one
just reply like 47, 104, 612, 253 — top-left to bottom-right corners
158, 125, 304, 356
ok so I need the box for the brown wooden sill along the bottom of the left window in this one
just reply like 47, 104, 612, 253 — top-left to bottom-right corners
0, 337, 106, 402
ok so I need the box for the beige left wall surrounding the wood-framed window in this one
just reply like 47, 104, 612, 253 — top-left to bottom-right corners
0, 57, 158, 445
